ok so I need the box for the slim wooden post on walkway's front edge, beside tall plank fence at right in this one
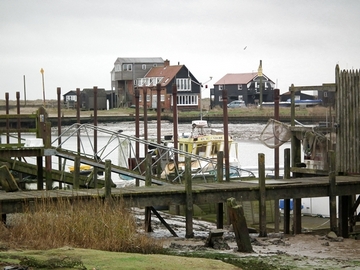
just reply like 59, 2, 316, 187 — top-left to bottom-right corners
329, 150, 337, 233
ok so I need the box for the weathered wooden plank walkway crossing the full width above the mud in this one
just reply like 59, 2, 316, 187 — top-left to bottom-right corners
0, 176, 360, 214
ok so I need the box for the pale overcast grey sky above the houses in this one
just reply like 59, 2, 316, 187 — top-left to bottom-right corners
0, 0, 360, 100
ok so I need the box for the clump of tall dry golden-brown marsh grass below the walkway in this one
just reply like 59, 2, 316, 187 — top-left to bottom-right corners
0, 198, 162, 254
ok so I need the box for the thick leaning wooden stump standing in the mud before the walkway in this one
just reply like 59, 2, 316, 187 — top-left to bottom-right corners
226, 198, 253, 252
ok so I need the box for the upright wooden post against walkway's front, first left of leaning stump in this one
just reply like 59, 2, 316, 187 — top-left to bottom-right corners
185, 156, 194, 238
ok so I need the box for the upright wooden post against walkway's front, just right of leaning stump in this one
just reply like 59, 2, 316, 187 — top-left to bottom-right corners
258, 153, 267, 237
